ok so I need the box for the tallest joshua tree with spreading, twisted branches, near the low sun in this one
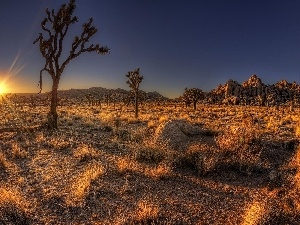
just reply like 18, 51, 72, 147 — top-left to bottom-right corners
33, 0, 109, 130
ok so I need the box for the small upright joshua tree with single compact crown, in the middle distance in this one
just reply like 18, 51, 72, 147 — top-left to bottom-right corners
126, 68, 144, 118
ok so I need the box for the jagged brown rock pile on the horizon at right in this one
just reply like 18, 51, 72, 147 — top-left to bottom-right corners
206, 75, 300, 106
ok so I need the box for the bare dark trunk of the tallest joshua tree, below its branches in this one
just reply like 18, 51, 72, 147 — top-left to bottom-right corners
48, 79, 59, 130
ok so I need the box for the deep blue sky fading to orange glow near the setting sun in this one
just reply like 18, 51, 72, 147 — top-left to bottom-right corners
0, 0, 300, 98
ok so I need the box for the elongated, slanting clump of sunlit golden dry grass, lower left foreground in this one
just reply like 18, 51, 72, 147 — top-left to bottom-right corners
66, 162, 105, 206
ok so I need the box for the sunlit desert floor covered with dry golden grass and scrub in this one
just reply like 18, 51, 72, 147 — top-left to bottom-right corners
0, 104, 300, 225
